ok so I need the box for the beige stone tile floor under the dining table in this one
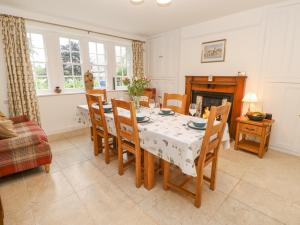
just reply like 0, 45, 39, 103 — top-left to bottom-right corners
0, 134, 300, 225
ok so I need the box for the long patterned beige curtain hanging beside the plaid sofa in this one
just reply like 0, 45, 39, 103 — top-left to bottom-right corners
0, 15, 40, 124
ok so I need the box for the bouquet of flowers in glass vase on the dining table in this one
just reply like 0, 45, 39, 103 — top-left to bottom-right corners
123, 77, 150, 109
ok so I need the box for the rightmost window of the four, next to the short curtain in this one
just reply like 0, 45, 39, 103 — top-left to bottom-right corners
115, 46, 131, 90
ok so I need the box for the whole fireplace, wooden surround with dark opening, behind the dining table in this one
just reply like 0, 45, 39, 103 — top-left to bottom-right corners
185, 76, 247, 138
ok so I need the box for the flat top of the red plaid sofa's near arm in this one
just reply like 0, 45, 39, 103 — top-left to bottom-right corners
0, 134, 43, 152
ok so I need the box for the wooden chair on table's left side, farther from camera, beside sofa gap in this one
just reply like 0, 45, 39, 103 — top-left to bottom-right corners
86, 94, 115, 164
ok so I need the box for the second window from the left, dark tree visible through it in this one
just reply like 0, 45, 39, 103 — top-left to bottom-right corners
59, 38, 83, 89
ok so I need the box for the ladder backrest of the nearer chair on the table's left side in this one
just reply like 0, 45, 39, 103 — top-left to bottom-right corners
112, 99, 140, 147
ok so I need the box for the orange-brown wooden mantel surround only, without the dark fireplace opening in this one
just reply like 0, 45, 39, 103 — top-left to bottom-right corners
185, 75, 247, 138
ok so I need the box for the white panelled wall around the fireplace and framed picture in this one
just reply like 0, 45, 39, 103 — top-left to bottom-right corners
149, 0, 300, 155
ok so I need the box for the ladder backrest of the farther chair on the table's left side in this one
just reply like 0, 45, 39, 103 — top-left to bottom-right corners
86, 94, 108, 133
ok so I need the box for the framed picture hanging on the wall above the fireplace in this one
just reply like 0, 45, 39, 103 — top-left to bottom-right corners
201, 39, 226, 63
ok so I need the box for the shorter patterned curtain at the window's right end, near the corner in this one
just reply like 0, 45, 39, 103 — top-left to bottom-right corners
132, 41, 144, 78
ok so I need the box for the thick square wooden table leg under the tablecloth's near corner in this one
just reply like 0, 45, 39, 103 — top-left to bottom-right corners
144, 150, 155, 190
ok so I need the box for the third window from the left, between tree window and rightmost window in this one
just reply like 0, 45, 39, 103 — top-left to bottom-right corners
89, 42, 107, 88
